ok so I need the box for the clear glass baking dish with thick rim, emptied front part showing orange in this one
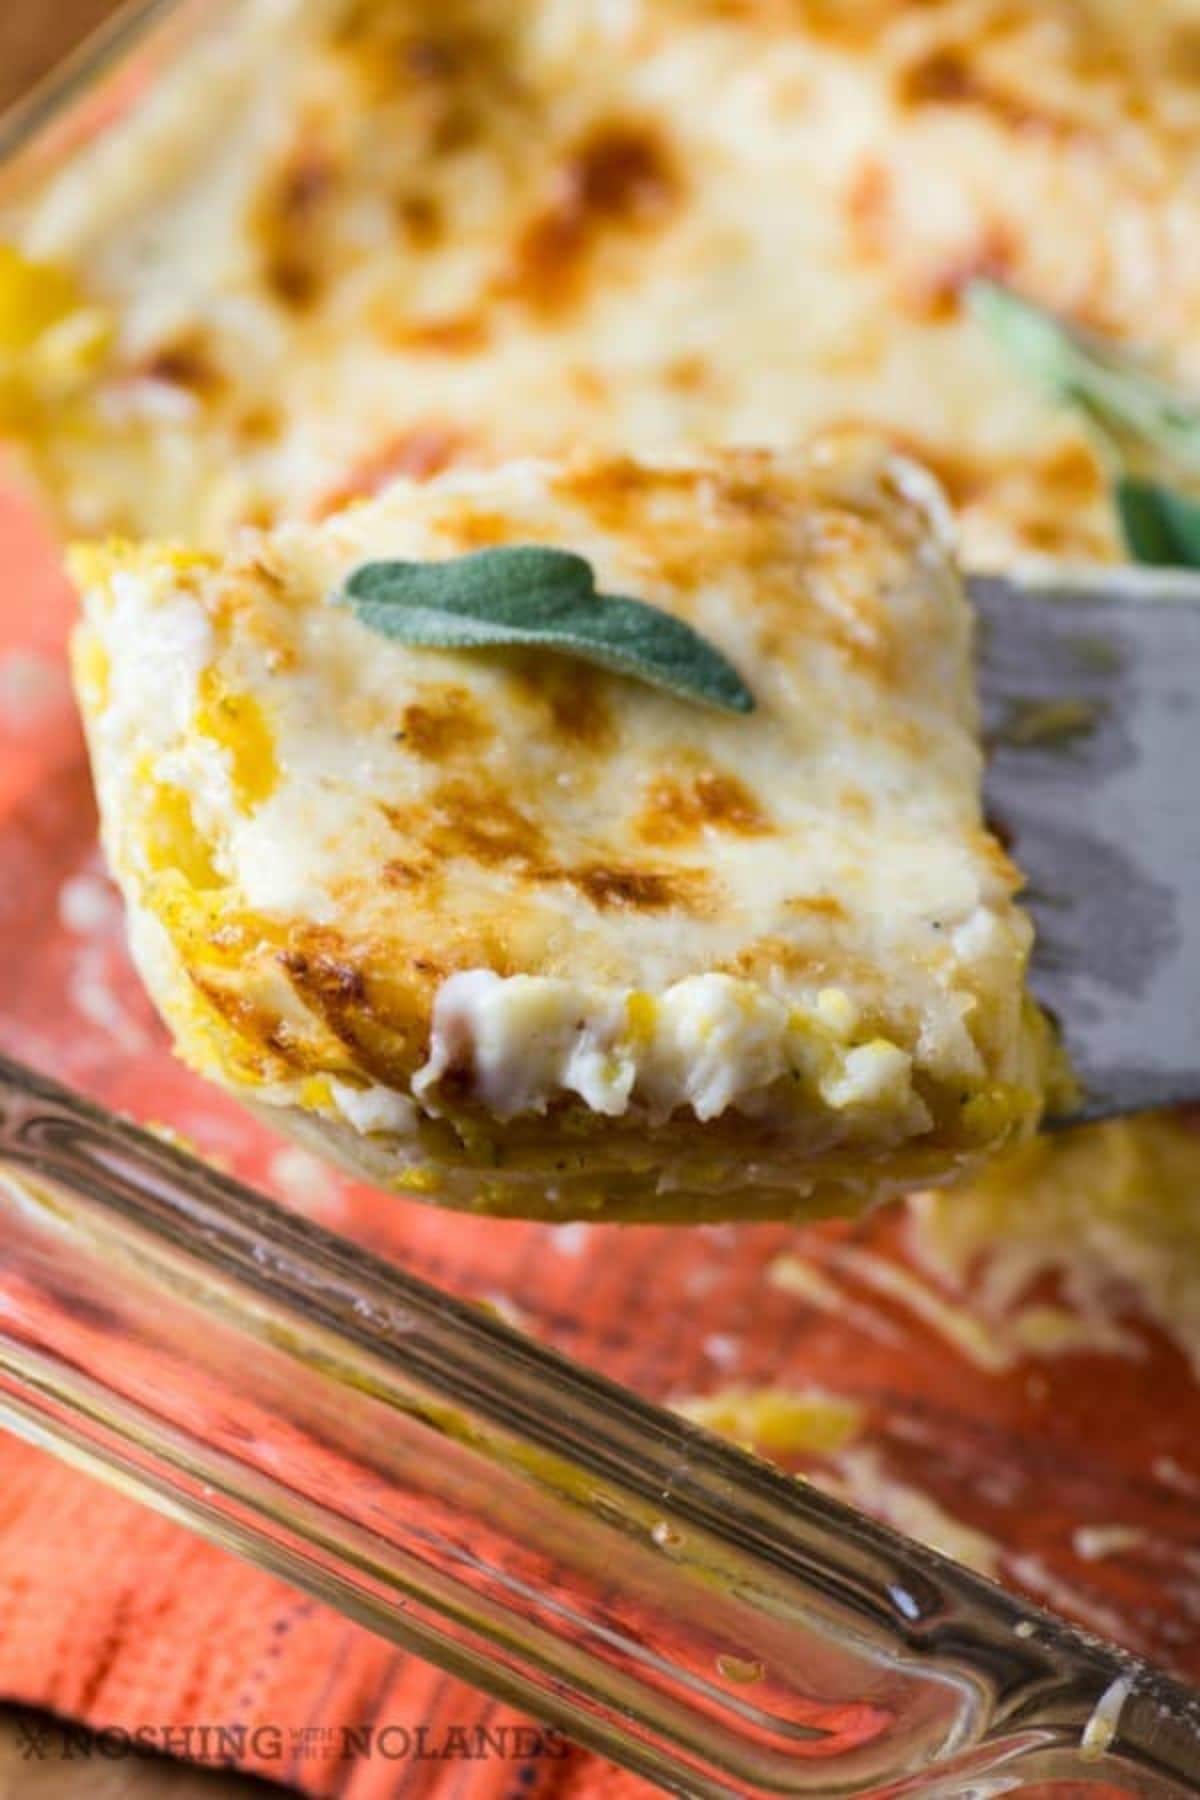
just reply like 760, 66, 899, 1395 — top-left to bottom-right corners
0, 0, 1200, 1796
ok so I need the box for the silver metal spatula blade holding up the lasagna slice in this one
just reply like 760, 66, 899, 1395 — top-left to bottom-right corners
970, 569, 1200, 1120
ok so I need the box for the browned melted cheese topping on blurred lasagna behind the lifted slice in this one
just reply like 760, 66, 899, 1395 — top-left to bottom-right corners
11, 0, 1200, 560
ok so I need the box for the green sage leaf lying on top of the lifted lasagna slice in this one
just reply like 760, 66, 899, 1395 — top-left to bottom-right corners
340, 544, 754, 713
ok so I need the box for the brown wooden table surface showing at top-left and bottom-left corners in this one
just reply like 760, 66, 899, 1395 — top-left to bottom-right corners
0, 0, 302, 1800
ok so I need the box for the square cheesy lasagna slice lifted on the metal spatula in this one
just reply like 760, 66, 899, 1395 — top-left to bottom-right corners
74, 437, 1047, 1220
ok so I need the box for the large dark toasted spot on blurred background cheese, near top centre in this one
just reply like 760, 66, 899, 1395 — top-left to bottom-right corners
500, 121, 680, 315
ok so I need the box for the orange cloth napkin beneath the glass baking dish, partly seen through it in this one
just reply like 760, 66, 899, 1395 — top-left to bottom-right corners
0, 495, 1200, 1800
